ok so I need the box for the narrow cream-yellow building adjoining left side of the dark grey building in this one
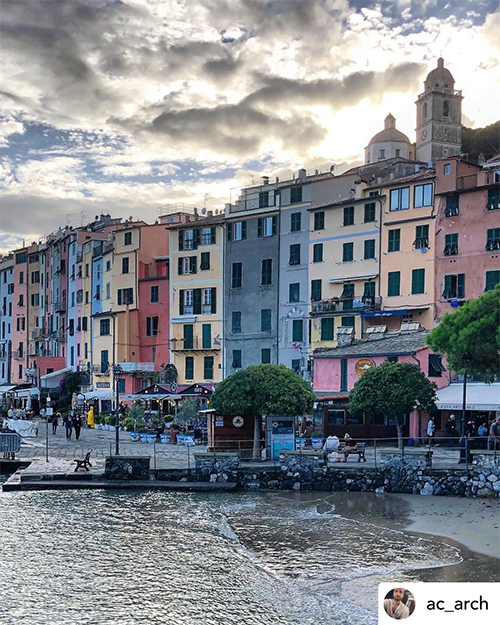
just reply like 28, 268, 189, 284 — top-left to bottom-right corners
170, 213, 224, 384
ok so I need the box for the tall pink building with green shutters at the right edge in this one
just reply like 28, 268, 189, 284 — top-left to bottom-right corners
435, 156, 500, 320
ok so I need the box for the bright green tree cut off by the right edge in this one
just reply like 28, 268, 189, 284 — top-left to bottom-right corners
427, 284, 500, 380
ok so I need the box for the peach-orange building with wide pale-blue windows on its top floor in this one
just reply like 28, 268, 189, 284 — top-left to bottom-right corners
376, 170, 436, 330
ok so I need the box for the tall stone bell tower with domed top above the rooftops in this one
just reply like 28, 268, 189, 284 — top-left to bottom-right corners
415, 58, 462, 163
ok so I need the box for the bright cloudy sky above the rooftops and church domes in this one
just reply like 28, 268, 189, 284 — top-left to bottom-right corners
0, 0, 500, 252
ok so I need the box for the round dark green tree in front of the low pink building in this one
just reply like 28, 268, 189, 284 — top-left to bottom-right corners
349, 361, 437, 449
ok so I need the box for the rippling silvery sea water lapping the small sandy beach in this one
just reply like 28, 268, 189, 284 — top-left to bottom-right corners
0, 491, 491, 625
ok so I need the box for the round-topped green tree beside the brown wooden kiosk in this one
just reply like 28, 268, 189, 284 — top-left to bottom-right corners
210, 365, 314, 459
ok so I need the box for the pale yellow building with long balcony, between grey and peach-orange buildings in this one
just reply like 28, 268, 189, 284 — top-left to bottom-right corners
309, 181, 383, 350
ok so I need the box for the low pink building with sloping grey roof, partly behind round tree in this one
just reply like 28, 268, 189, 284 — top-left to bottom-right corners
313, 330, 452, 438
